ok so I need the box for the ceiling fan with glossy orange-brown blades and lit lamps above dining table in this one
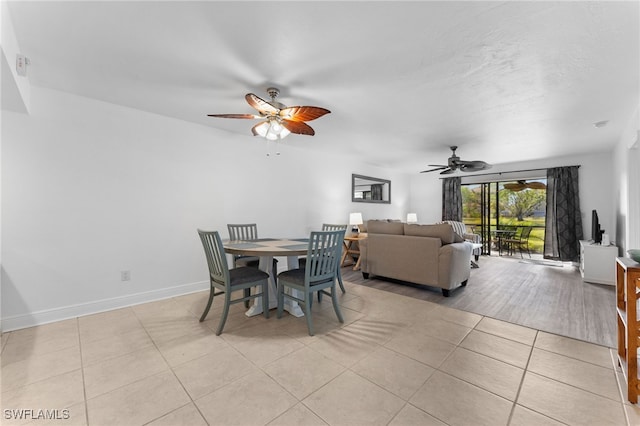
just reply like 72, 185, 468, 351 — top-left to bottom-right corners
207, 87, 331, 140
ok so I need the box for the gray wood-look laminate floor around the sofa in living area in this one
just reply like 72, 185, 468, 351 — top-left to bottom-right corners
342, 256, 616, 348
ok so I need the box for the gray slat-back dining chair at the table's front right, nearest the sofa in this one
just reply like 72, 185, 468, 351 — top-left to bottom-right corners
278, 230, 345, 336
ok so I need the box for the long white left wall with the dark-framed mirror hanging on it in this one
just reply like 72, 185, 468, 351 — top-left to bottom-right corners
1, 86, 409, 330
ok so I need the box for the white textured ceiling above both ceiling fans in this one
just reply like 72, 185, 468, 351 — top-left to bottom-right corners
9, 1, 640, 172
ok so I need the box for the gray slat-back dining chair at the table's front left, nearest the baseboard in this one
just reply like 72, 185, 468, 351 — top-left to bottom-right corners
198, 229, 269, 336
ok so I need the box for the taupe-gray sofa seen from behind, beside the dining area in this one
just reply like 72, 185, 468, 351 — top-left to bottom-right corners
360, 220, 471, 297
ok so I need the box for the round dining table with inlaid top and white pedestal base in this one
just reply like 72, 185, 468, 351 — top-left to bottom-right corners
222, 238, 309, 317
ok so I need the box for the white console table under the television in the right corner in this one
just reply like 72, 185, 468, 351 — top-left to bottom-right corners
580, 241, 618, 285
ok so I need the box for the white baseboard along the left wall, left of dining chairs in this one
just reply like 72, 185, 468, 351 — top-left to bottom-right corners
0, 281, 209, 332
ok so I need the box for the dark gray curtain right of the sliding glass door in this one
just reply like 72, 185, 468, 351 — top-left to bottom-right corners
544, 166, 582, 262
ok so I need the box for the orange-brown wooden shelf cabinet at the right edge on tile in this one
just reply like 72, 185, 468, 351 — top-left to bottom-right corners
615, 257, 640, 404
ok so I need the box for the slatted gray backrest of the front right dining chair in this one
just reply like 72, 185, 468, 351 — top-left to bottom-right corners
305, 229, 345, 285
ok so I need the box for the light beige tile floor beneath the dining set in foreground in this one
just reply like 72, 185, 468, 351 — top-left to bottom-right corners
1, 282, 640, 426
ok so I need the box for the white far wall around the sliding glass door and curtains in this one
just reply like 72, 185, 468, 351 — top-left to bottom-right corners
410, 152, 615, 239
